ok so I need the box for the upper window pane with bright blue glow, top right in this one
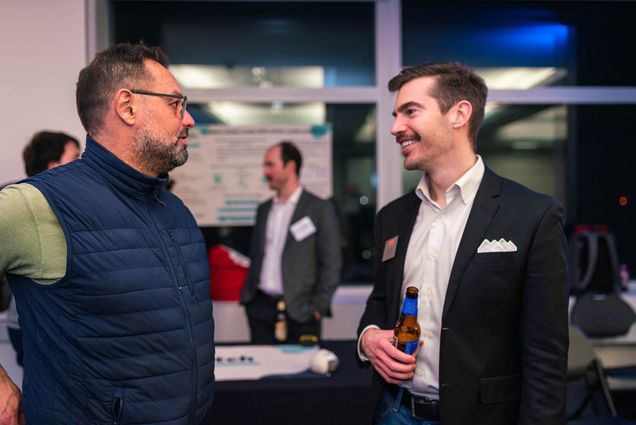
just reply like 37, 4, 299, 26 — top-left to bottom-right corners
402, 0, 636, 89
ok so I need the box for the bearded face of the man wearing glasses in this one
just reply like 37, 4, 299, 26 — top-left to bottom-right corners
133, 60, 194, 175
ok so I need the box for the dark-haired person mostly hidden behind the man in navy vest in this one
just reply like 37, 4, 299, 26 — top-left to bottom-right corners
7, 131, 80, 366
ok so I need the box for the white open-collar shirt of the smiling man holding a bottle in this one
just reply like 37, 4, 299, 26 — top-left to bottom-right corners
402, 155, 484, 399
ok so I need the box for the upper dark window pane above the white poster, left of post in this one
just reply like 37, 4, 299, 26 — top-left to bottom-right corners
113, 1, 375, 87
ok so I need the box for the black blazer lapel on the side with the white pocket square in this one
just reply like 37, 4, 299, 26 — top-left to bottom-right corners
442, 167, 501, 318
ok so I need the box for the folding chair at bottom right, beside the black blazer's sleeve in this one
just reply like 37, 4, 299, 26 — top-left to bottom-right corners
568, 326, 636, 425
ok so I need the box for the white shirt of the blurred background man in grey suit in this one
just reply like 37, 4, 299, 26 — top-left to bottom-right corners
258, 186, 303, 296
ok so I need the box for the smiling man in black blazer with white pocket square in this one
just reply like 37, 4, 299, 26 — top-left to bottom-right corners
358, 63, 568, 425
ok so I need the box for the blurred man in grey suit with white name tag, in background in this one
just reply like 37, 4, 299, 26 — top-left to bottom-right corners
241, 142, 342, 344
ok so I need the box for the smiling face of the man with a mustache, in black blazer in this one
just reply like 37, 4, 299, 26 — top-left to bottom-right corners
391, 77, 453, 171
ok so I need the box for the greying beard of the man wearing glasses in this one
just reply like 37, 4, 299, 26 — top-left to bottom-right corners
134, 129, 188, 175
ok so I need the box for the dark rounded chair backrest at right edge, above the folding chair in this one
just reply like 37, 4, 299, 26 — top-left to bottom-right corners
570, 293, 636, 338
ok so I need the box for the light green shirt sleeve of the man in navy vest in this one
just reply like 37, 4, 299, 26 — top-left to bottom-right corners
0, 183, 66, 284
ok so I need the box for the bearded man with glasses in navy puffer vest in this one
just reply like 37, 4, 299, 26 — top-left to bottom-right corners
0, 43, 214, 425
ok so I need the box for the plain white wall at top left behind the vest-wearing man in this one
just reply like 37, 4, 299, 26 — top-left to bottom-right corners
0, 0, 87, 184
